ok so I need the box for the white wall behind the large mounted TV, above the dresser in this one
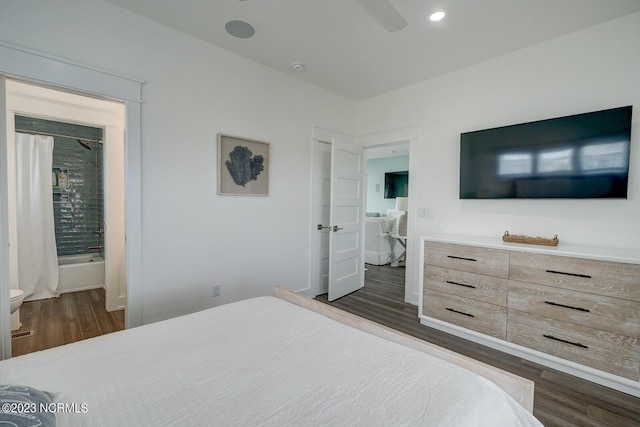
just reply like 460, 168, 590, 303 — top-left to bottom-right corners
356, 13, 640, 300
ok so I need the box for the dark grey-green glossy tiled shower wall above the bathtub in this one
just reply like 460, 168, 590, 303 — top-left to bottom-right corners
16, 116, 104, 256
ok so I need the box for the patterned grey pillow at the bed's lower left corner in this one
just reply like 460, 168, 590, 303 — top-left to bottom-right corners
0, 385, 56, 427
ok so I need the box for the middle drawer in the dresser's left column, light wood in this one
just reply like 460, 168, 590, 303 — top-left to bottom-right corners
424, 265, 508, 307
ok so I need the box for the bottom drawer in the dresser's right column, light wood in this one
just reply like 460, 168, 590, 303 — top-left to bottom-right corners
507, 310, 640, 381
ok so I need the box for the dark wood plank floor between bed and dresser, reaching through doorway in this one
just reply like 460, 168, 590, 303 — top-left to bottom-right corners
316, 265, 640, 427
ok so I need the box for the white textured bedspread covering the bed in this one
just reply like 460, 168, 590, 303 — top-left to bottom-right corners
0, 297, 541, 427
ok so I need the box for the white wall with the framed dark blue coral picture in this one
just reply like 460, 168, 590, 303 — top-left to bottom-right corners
0, 0, 355, 323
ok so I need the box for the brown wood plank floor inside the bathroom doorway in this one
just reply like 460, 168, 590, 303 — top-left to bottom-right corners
11, 289, 124, 356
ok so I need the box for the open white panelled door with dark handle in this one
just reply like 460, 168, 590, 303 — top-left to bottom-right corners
328, 139, 365, 301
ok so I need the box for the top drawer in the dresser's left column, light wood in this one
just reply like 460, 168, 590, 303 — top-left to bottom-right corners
424, 241, 509, 278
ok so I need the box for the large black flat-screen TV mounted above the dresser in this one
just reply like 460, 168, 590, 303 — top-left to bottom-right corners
460, 106, 633, 199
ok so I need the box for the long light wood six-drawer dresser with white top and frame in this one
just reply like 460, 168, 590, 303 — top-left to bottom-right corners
419, 236, 640, 397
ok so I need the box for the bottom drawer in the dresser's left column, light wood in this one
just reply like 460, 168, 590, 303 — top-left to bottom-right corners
422, 289, 507, 339
